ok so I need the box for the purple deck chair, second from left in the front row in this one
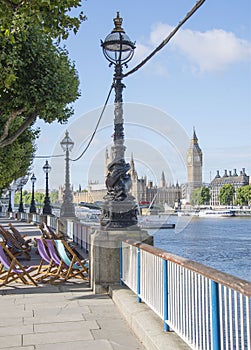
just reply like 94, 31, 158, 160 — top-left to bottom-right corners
34, 238, 63, 282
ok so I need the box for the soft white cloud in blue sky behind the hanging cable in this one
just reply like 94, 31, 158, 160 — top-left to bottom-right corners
138, 23, 251, 72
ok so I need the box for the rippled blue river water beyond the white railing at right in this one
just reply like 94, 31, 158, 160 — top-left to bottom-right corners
152, 216, 251, 282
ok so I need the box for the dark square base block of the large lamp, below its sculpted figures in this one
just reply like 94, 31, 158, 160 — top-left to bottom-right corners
100, 198, 138, 230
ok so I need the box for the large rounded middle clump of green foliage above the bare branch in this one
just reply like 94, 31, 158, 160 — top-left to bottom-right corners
0, 27, 79, 147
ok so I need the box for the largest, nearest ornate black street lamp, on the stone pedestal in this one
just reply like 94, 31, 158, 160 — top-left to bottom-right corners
100, 12, 137, 229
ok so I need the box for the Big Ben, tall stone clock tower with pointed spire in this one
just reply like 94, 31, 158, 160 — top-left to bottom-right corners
187, 129, 202, 200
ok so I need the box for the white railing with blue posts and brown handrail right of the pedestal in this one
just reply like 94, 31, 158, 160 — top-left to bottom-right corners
120, 241, 251, 350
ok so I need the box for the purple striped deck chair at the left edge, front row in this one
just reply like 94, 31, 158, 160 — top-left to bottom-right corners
0, 243, 37, 286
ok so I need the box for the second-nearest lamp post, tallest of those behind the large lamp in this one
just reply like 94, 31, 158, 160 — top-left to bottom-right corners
60, 131, 76, 218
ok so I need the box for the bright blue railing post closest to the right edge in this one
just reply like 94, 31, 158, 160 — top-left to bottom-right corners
211, 281, 220, 350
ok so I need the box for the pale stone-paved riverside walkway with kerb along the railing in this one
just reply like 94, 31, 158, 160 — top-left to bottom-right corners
0, 218, 189, 350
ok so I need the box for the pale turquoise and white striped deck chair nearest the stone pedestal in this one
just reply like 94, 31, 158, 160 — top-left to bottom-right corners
55, 240, 88, 280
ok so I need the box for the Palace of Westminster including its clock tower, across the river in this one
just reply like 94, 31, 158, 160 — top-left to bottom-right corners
65, 130, 202, 208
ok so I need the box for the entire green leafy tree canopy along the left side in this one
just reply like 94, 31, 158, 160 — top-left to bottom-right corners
0, 0, 86, 188
